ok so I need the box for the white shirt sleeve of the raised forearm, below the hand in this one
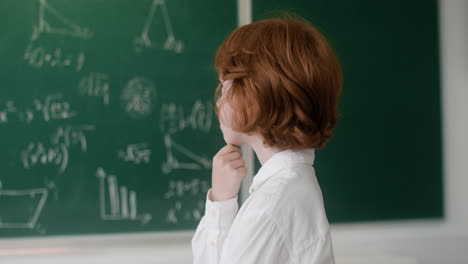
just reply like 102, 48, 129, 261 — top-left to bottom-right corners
192, 189, 239, 264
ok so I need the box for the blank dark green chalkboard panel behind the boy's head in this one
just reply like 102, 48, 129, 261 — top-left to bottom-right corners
253, 0, 443, 223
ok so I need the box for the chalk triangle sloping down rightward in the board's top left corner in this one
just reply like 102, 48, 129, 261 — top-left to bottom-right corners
31, 0, 93, 40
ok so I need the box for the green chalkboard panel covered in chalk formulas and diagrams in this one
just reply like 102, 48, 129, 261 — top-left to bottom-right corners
0, 0, 237, 237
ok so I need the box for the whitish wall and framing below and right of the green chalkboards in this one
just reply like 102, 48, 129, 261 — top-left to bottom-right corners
0, 0, 468, 264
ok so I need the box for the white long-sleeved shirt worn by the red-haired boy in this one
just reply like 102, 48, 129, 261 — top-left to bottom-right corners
192, 149, 334, 264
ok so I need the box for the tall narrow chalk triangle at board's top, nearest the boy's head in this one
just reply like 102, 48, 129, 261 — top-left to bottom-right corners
134, 0, 184, 53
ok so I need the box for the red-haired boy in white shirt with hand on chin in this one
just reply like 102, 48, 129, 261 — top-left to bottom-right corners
192, 18, 342, 264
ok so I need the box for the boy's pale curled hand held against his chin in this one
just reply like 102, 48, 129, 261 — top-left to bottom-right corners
210, 145, 247, 202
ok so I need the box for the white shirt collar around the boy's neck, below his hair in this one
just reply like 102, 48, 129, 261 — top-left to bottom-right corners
249, 148, 315, 193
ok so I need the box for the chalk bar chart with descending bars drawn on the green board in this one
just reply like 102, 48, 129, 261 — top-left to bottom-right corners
96, 168, 152, 225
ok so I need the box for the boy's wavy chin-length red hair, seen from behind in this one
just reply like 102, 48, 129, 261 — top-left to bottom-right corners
215, 18, 342, 149
